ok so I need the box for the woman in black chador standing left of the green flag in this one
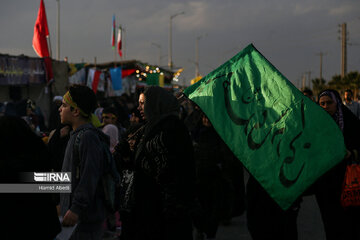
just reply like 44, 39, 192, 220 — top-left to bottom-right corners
116, 87, 195, 240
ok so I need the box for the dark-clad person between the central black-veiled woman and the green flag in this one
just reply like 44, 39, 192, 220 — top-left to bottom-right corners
194, 114, 234, 239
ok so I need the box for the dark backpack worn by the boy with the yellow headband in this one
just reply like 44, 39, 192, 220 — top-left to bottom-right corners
74, 128, 120, 213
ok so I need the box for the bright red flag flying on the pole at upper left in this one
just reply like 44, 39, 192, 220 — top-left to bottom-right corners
32, 0, 53, 81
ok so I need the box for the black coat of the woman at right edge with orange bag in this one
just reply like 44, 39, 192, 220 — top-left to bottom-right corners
314, 105, 360, 240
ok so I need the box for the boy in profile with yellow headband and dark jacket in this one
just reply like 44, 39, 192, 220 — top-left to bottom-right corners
59, 85, 106, 240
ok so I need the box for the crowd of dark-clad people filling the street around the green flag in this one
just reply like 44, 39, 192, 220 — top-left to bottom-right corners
0, 85, 360, 240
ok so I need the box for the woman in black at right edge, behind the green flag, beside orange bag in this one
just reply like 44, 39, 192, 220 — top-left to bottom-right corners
314, 89, 360, 240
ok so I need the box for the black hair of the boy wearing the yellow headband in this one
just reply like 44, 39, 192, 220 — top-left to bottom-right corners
69, 85, 97, 116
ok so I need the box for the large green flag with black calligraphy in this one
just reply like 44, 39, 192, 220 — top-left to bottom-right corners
184, 45, 346, 210
